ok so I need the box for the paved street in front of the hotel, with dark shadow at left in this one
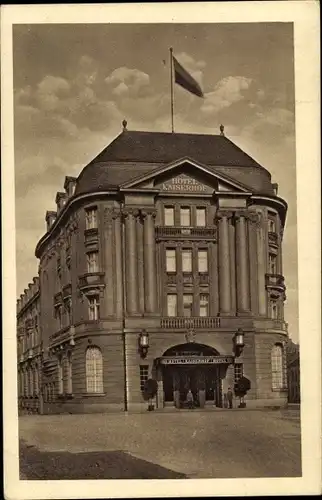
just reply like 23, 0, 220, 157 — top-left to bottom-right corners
19, 408, 301, 479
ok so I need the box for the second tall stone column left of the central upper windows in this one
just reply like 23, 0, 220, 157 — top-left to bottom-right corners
124, 208, 139, 314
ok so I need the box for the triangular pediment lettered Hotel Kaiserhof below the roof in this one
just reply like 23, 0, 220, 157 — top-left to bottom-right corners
122, 158, 250, 195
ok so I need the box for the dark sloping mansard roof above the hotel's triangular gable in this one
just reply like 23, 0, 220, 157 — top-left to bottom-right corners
75, 130, 274, 195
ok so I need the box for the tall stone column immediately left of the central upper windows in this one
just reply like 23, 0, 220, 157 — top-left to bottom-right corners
141, 209, 157, 313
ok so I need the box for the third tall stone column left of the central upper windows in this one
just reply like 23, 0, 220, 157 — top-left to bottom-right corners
113, 212, 123, 318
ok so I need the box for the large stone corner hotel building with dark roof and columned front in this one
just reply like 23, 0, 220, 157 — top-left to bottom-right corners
18, 128, 287, 413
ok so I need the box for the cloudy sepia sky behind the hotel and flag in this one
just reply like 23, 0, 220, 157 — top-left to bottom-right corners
13, 23, 298, 341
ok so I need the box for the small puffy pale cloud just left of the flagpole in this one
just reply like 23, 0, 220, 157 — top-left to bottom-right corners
105, 67, 150, 96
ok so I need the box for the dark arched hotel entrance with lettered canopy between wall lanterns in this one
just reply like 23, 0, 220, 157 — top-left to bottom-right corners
161, 343, 228, 408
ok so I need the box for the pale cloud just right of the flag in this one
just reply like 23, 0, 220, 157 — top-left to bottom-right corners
201, 76, 252, 113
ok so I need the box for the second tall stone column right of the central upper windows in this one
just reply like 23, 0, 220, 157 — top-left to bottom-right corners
235, 211, 250, 314
